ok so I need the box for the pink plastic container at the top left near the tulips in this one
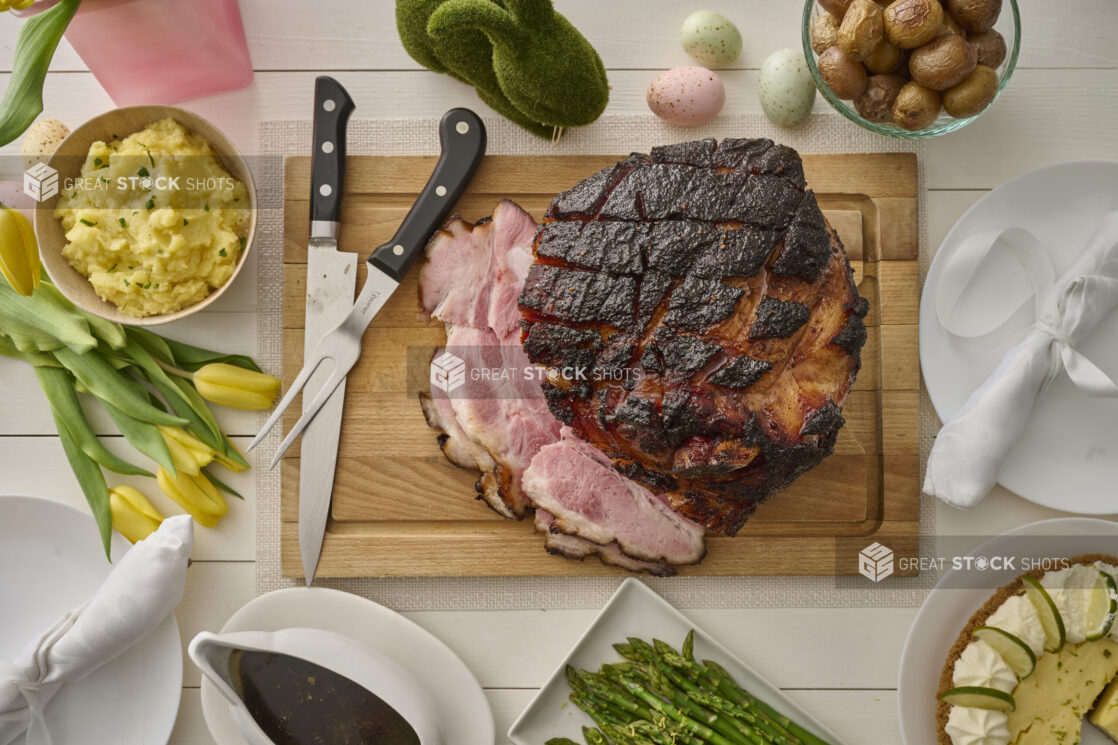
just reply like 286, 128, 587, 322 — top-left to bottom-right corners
25, 0, 253, 106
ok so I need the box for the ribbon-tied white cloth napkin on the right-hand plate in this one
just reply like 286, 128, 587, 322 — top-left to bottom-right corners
923, 211, 1118, 508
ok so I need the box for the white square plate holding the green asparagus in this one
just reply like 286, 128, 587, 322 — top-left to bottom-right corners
509, 577, 842, 745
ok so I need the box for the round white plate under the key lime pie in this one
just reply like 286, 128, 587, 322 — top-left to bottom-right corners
897, 518, 1118, 745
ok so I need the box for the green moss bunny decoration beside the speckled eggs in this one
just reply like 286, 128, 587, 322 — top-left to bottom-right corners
396, 0, 609, 140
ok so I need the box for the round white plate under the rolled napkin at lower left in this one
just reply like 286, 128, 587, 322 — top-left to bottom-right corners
0, 497, 182, 745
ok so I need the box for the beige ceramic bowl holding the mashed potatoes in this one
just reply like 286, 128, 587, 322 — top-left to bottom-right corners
35, 105, 257, 326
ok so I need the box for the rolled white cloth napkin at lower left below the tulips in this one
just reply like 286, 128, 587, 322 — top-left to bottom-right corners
0, 515, 195, 745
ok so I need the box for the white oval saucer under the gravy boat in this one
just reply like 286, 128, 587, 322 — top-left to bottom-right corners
201, 587, 494, 745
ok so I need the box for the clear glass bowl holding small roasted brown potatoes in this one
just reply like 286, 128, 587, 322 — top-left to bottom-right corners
803, 0, 1021, 140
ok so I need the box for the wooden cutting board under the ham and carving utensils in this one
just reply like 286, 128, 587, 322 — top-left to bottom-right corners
282, 153, 919, 577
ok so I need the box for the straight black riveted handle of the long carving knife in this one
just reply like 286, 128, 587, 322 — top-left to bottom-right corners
311, 75, 356, 228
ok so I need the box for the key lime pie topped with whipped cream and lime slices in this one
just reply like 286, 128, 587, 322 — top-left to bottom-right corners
936, 555, 1118, 745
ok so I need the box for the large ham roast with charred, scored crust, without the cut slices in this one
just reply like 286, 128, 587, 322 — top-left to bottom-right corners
518, 140, 868, 534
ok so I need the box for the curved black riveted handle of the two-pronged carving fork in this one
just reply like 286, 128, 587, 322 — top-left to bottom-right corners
369, 109, 485, 282
